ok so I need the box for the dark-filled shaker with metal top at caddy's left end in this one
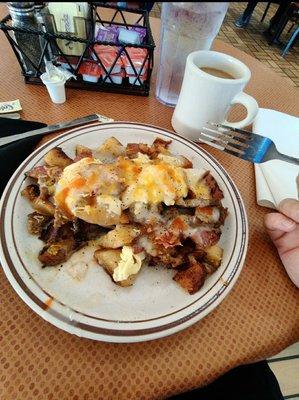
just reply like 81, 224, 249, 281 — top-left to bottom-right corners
7, 1, 41, 76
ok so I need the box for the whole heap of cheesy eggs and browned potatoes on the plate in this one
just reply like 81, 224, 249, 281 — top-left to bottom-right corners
22, 137, 227, 294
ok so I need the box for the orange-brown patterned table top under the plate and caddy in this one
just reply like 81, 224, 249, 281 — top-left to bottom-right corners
0, 7, 299, 400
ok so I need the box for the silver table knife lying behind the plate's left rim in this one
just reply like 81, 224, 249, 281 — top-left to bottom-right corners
0, 114, 113, 147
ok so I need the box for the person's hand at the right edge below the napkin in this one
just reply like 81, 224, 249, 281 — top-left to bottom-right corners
265, 199, 299, 287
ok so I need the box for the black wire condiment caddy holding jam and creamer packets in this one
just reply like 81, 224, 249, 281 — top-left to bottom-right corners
0, 2, 155, 96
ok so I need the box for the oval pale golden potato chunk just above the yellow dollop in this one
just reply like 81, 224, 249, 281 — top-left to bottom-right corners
97, 225, 140, 249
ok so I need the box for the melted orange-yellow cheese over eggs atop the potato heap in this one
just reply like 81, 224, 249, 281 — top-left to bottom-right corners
54, 153, 197, 223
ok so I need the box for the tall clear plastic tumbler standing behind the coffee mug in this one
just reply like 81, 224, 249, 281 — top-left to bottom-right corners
156, 2, 228, 107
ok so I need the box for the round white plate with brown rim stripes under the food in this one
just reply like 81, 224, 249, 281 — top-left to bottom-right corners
0, 123, 248, 342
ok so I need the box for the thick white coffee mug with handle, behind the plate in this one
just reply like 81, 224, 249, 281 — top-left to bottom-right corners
171, 50, 258, 140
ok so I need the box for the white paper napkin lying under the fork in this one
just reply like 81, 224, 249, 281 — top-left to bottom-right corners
253, 108, 299, 208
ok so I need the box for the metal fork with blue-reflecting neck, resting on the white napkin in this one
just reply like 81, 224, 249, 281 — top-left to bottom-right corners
202, 122, 299, 165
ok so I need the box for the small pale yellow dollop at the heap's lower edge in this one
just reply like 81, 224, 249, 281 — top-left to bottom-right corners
113, 246, 145, 282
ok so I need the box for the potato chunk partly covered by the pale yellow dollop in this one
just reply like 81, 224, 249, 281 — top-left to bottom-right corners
94, 249, 136, 287
